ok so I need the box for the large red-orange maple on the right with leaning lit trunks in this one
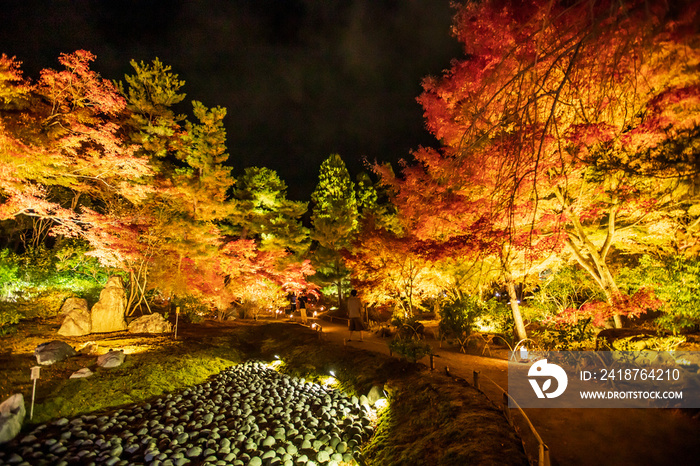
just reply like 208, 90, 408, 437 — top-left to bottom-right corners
378, 1, 700, 338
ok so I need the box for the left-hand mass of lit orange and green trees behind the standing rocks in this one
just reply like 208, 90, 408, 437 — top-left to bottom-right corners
0, 51, 314, 312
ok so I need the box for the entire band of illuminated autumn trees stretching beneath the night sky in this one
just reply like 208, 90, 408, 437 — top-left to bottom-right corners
0, 0, 700, 340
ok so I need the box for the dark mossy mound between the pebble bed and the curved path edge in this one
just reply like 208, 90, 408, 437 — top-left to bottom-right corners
365, 371, 527, 466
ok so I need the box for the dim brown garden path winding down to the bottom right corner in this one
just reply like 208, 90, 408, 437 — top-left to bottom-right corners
304, 321, 700, 466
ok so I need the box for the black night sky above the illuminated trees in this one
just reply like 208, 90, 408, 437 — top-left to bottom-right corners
0, 0, 461, 200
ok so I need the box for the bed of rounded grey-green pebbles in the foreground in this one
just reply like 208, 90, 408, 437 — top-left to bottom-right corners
0, 361, 373, 466
